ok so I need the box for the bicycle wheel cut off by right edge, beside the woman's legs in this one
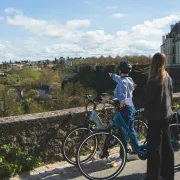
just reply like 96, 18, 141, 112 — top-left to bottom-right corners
170, 123, 180, 170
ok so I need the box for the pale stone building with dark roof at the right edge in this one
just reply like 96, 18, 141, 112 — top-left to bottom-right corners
161, 21, 180, 65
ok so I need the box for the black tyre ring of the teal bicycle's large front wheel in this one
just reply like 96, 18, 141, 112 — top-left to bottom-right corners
76, 129, 127, 180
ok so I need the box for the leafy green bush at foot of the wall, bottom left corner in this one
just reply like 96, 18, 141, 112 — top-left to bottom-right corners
0, 144, 42, 177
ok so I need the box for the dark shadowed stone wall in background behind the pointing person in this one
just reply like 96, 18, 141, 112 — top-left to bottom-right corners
67, 64, 180, 108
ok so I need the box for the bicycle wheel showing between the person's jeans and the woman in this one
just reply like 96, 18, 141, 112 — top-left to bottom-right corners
134, 120, 148, 144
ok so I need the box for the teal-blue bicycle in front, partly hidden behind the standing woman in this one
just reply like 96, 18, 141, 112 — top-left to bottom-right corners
76, 99, 180, 180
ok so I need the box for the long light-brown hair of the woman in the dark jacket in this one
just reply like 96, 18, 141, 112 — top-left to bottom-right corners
148, 53, 167, 84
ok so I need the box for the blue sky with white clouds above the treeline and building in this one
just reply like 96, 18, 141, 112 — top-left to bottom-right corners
0, 0, 180, 61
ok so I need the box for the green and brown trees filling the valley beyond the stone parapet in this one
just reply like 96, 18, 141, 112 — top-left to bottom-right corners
0, 56, 150, 117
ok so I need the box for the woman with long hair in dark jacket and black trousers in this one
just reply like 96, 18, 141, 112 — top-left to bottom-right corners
145, 53, 174, 180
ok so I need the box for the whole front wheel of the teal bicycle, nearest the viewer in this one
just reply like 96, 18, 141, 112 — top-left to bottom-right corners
76, 130, 127, 180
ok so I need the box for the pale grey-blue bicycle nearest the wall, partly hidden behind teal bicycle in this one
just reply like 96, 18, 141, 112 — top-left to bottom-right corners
62, 94, 111, 165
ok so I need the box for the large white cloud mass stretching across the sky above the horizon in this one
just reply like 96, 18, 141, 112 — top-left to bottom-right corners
0, 11, 180, 60
